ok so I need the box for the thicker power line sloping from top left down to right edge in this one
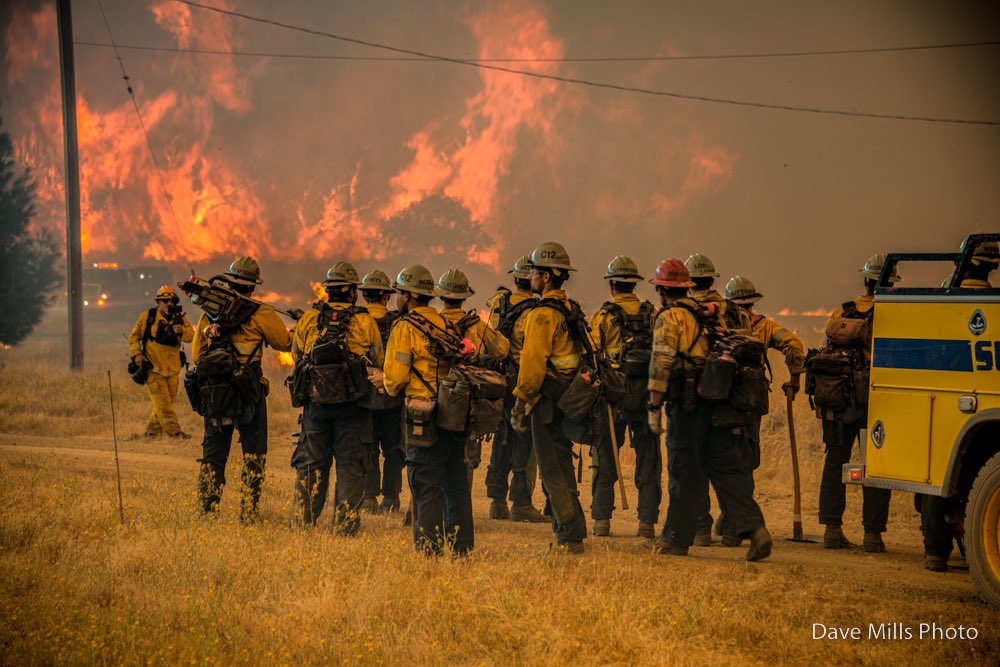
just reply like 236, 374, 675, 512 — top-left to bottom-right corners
175, 0, 1000, 126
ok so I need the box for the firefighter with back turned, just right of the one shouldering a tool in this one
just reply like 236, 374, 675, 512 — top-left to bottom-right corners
292, 262, 383, 535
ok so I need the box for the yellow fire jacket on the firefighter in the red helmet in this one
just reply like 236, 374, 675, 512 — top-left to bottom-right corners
647, 298, 708, 394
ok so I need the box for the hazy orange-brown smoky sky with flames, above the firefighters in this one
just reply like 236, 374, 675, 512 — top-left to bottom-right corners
0, 0, 1000, 324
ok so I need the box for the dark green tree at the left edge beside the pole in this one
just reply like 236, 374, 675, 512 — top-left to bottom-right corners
0, 119, 62, 345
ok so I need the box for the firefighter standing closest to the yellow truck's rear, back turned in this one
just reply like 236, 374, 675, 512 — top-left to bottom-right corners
817, 254, 899, 553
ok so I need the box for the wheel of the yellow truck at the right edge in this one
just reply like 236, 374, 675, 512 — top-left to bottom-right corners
966, 454, 1000, 608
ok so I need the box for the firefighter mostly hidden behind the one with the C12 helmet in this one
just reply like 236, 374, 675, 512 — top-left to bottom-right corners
486, 255, 549, 523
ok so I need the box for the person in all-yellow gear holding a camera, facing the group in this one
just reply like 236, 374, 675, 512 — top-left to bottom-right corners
128, 285, 194, 440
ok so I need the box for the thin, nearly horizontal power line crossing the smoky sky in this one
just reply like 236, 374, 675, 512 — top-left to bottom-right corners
73, 40, 1000, 63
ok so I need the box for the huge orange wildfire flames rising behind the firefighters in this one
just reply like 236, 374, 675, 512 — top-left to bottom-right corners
0, 0, 733, 298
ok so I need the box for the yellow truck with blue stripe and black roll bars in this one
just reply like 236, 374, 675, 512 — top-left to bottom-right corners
843, 234, 1000, 607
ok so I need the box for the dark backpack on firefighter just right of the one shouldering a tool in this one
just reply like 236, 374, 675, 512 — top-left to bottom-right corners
290, 302, 371, 407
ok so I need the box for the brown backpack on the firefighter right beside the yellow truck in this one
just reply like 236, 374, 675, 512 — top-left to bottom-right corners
805, 301, 875, 423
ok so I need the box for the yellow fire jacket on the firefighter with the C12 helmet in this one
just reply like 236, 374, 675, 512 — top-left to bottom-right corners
514, 290, 583, 406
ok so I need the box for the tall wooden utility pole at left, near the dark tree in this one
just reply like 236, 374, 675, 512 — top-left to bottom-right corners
56, 0, 83, 370
